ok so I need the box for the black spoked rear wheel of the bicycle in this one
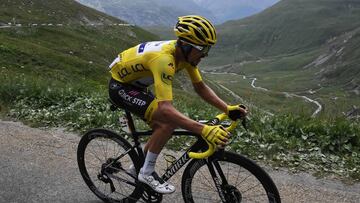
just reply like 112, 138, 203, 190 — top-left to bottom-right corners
77, 129, 143, 203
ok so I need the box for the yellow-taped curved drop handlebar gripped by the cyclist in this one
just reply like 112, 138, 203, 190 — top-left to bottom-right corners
188, 113, 245, 159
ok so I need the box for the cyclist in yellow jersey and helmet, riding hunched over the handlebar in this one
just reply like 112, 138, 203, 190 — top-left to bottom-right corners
109, 15, 247, 194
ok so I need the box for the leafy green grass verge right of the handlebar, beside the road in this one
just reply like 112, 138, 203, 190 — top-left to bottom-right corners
231, 112, 360, 181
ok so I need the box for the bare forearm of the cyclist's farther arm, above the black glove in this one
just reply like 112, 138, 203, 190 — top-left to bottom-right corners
193, 81, 227, 112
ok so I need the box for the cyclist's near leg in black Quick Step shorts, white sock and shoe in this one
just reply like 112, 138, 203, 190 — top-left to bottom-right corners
109, 79, 175, 193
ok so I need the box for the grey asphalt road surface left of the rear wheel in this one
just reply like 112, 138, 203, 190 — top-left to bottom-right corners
0, 122, 102, 203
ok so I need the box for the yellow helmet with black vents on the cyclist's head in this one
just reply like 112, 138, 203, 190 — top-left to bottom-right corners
174, 15, 216, 46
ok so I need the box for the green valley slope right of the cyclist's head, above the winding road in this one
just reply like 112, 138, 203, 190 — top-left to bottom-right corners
195, 0, 360, 117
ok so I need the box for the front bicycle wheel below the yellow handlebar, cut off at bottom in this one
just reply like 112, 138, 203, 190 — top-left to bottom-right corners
181, 152, 281, 203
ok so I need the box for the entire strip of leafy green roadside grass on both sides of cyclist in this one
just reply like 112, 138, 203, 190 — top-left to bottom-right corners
0, 73, 360, 181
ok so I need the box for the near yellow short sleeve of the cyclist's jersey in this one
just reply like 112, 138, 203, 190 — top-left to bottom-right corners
149, 55, 175, 101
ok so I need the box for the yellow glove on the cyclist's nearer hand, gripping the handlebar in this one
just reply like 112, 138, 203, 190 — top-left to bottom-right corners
201, 125, 229, 145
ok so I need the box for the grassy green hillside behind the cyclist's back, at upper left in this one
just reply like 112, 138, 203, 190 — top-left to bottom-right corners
0, 0, 156, 84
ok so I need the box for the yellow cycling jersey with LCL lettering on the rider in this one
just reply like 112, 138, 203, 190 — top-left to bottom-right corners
109, 40, 202, 101
